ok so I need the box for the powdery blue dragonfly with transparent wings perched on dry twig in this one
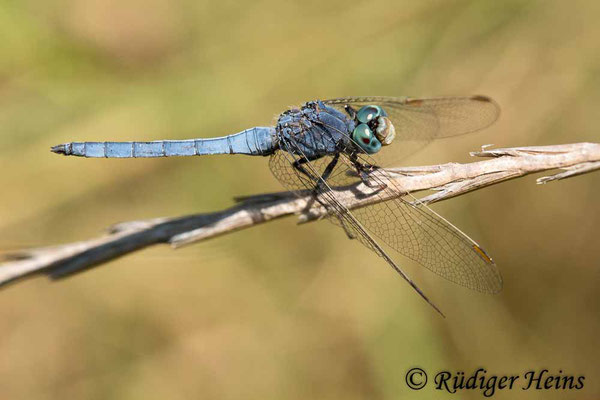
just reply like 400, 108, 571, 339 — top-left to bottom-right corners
51, 96, 502, 316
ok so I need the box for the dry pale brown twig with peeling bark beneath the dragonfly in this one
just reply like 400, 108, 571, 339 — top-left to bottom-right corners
0, 143, 600, 286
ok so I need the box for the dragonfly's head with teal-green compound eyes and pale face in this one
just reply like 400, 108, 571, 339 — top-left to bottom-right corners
352, 105, 396, 154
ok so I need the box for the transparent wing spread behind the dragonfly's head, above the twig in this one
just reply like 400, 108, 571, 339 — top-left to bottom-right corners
324, 96, 500, 167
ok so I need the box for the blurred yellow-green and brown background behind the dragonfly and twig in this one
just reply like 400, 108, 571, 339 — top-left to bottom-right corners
0, 0, 600, 399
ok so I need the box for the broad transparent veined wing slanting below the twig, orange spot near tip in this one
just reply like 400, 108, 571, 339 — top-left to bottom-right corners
352, 150, 502, 293
